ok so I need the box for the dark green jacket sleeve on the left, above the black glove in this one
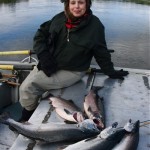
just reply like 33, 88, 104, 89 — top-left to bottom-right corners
33, 20, 51, 56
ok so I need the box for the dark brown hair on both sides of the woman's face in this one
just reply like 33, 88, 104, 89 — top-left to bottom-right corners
61, 0, 92, 21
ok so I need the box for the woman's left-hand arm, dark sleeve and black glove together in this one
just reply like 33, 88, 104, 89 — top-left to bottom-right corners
33, 21, 57, 77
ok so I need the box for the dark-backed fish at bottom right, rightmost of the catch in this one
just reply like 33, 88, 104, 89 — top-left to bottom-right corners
113, 121, 140, 150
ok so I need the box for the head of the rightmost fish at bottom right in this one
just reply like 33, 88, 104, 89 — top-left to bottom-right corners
124, 119, 140, 132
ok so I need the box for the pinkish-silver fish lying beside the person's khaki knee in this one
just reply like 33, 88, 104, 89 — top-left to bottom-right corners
49, 96, 85, 123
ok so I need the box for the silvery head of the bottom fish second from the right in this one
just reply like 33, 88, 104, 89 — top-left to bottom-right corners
99, 122, 118, 139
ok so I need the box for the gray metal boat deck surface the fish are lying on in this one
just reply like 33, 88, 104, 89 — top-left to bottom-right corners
2, 69, 150, 150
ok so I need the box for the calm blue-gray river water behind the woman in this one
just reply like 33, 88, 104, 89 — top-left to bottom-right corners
0, 0, 150, 69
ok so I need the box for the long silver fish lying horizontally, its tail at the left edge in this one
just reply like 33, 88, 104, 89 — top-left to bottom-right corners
0, 113, 100, 143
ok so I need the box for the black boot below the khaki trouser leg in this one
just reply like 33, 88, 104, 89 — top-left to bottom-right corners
18, 108, 34, 122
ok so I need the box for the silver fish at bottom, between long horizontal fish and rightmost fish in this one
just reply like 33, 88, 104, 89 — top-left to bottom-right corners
63, 122, 138, 150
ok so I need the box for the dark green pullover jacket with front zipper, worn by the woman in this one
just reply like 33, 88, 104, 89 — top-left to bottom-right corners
33, 12, 114, 75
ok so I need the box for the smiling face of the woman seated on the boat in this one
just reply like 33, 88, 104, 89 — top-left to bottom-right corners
69, 0, 86, 17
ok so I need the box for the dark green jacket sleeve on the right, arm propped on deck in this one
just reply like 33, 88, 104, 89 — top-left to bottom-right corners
94, 25, 114, 75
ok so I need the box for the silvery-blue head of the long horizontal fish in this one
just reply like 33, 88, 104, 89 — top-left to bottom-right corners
78, 119, 100, 133
